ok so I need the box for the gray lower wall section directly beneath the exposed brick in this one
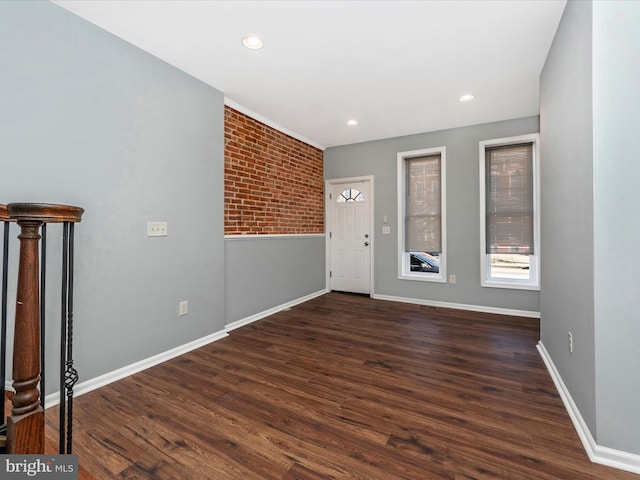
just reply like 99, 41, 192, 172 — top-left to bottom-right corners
225, 235, 326, 324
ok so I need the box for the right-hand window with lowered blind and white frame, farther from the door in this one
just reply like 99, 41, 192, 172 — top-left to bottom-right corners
480, 134, 540, 290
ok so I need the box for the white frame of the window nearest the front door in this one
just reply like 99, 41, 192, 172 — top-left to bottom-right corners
397, 147, 447, 283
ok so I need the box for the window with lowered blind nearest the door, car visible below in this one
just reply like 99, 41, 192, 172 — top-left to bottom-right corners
398, 147, 447, 282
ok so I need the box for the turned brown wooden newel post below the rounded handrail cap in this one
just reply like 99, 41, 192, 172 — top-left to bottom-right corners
7, 220, 44, 453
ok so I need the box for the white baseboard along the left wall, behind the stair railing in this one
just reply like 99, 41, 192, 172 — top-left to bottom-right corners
44, 331, 228, 408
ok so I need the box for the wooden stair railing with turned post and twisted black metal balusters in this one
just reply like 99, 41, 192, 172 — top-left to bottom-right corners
0, 203, 84, 454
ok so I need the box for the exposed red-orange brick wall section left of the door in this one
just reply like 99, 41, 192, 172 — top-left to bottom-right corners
224, 106, 324, 235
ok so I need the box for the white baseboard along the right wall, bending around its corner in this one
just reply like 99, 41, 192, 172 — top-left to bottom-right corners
537, 341, 640, 473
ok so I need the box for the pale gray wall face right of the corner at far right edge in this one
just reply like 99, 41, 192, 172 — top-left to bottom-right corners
593, 1, 640, 454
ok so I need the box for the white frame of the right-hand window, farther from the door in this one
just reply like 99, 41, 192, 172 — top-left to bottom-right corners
479, 133, 540, 290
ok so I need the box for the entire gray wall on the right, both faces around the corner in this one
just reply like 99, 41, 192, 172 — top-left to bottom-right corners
540, 1, 640, 455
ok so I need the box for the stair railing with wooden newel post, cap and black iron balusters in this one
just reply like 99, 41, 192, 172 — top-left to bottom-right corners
0, 203, 84, 454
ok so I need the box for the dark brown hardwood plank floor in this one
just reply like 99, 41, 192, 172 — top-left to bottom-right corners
46, 293, 639, 480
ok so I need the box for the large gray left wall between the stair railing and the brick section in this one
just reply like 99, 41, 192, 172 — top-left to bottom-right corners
0, 2, 225, 391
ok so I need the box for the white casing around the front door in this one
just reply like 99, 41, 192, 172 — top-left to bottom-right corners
324, 175, 376, 297
